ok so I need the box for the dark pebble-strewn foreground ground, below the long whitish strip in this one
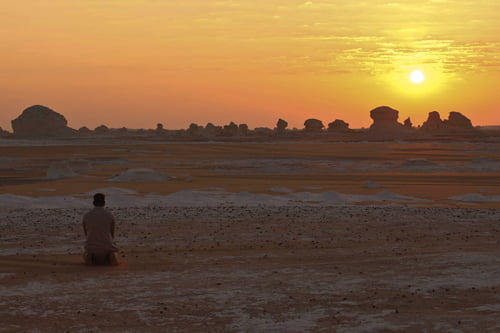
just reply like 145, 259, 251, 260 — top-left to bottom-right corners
0, 205, 500, 332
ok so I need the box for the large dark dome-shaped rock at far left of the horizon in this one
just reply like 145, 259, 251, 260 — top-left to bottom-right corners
11, 105, 76, 138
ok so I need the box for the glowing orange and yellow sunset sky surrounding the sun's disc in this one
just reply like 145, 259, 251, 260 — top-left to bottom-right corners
0, 0, 500, 130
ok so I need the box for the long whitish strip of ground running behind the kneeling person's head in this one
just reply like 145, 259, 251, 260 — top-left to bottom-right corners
0, 188, 425, 208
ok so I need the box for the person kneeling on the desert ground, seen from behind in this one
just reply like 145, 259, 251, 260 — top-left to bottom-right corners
83, 193, 118, 265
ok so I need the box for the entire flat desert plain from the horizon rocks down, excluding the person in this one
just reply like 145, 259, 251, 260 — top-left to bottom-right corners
0, 140, 500, 332
